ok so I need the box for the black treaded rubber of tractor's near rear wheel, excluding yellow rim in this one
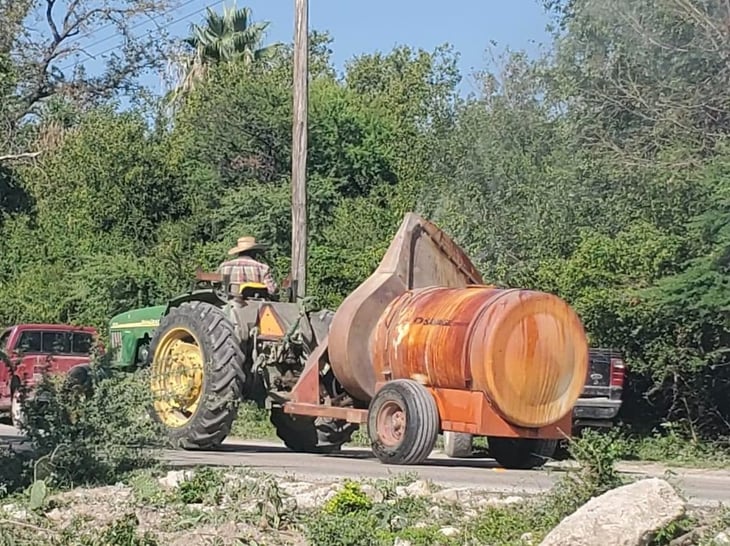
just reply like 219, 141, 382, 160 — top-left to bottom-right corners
149, 301, 247, 450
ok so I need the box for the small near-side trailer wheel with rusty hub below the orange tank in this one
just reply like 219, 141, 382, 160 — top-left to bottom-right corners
368, 379, 440, 464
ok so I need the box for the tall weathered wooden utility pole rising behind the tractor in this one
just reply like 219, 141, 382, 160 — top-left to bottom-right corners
291, 0, 309, 301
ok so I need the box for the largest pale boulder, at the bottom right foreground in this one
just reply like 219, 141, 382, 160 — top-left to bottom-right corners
540, 478, 685, 546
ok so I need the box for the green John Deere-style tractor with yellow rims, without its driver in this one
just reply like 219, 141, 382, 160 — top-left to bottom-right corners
110, 271, 358, 453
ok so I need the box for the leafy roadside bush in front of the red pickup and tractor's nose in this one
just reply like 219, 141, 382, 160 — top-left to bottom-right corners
8, 352, 163, 492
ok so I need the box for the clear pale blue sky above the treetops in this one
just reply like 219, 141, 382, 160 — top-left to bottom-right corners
54, 0, 549, 98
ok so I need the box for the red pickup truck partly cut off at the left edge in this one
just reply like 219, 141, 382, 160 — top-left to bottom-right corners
0, 324, 97, 427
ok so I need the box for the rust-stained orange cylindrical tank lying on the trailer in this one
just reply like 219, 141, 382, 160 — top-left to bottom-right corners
370, 286, 588, 427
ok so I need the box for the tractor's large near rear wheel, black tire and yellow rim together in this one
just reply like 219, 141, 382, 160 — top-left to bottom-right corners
150, 301, 246, 449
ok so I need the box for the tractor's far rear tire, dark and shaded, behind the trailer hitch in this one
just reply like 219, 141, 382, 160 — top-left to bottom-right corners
270, 408, 358, 454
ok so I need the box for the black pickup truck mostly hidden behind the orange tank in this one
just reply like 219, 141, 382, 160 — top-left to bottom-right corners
444, 347, 626, 457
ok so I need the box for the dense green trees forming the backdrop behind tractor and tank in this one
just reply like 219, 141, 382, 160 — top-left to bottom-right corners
0, 0, 730, 437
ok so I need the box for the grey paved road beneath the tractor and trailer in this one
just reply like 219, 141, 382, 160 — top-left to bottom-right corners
0, 425, 730, 505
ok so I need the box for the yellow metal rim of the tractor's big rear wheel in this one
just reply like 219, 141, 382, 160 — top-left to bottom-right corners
151, 326, 203, 428
